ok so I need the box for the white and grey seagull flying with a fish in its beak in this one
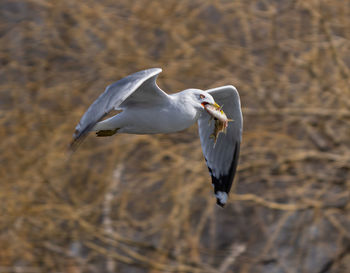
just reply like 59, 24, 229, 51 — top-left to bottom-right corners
71, 68, 243, 207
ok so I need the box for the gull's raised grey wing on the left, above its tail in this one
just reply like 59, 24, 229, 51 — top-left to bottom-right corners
71, 68, 168, 148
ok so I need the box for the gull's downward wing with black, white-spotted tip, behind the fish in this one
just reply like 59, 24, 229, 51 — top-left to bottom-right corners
198, 85, 243, 207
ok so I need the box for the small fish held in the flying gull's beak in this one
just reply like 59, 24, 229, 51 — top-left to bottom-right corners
204, 103, 232, 145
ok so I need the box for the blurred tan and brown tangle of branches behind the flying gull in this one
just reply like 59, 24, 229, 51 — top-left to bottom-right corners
0, 0, 350, 273
